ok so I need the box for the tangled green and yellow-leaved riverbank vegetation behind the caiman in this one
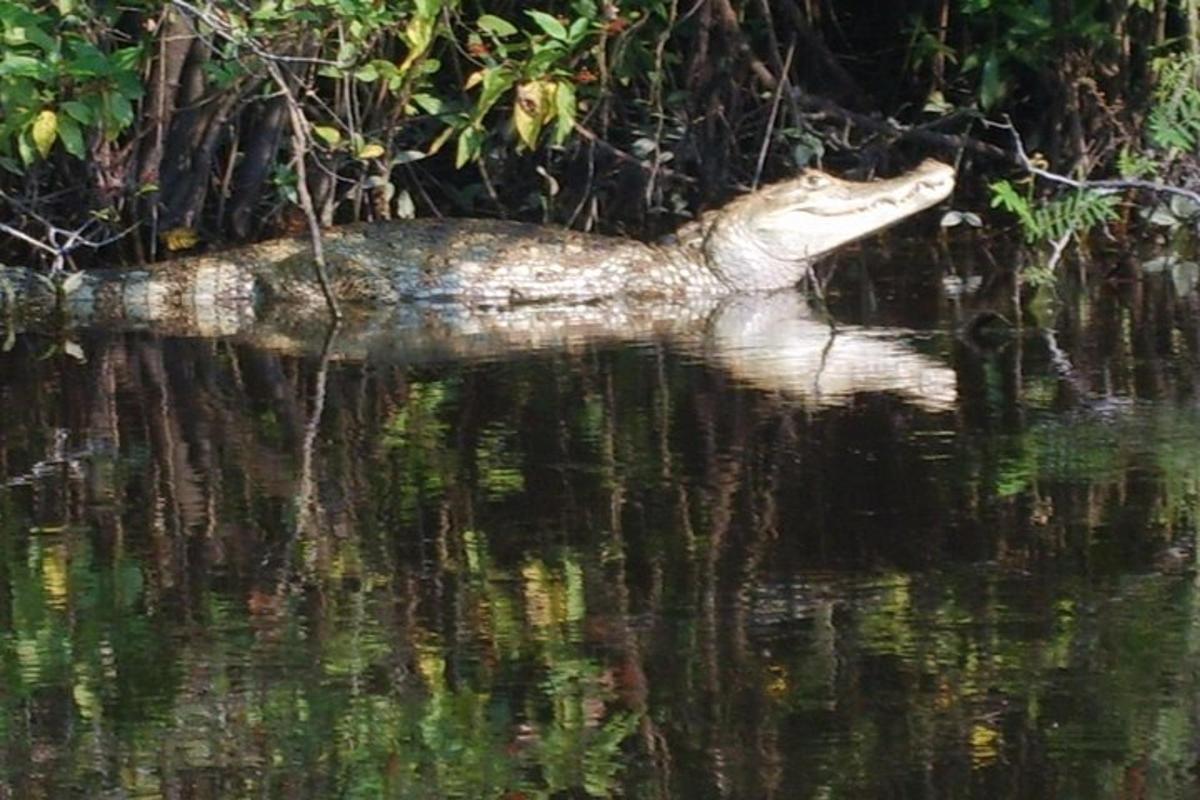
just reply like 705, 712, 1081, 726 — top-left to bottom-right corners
0, 0, 1200, 267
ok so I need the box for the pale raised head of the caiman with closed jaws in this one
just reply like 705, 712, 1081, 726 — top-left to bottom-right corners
702, 161, 954, 290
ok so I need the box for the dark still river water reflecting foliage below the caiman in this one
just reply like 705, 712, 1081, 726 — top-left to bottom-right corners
0, 248, 1200, 800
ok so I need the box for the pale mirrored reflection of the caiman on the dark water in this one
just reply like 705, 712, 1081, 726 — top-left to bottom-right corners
211, 289, 956, 410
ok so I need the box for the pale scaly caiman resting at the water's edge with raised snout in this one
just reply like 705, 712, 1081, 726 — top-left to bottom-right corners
0, 161, 954, 333
